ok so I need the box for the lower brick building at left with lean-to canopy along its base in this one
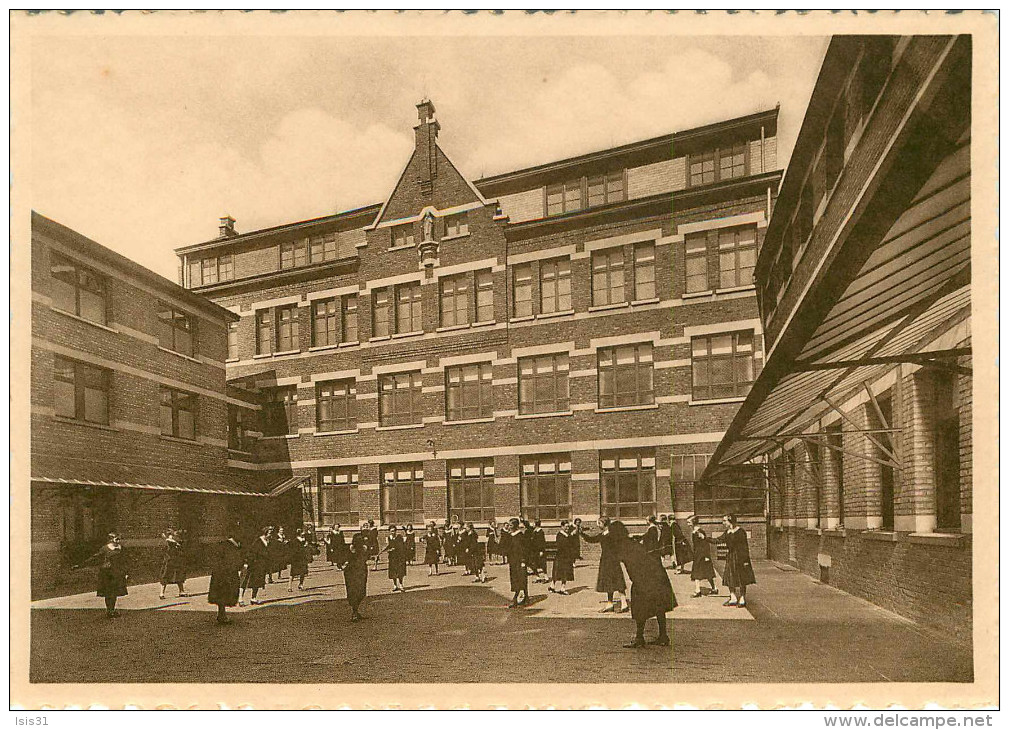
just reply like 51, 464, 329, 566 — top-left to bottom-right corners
31, 213, 300, 597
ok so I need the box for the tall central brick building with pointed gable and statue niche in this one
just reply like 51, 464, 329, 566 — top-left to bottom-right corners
178, 101, 781, 549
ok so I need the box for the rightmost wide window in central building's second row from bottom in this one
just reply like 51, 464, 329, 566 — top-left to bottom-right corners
691, 331, 754, 401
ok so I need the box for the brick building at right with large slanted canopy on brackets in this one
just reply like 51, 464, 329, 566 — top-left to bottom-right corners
704, 36, 973, 643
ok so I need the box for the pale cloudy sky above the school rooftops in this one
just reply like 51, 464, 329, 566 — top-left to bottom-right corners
27, 30, 828, 280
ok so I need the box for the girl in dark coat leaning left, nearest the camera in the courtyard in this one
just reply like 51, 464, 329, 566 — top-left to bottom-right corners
609, 521, 676, 649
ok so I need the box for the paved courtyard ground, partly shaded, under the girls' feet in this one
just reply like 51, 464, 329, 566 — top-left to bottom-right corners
30, 562, 972, 683
